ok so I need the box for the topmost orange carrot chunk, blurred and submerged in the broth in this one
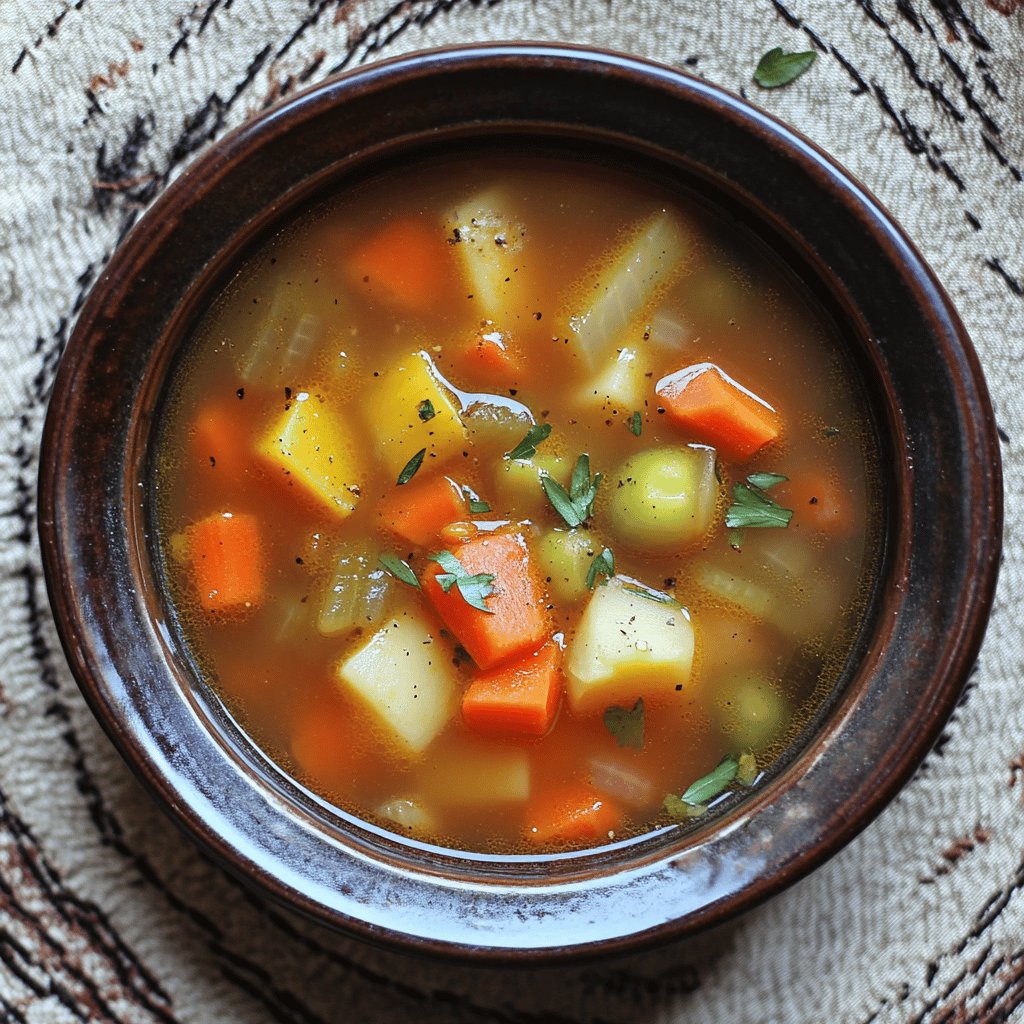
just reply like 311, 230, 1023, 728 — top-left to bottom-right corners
348, 217, 447, 310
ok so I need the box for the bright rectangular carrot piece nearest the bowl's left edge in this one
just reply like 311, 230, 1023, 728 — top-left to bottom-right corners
187, 512, 264, 611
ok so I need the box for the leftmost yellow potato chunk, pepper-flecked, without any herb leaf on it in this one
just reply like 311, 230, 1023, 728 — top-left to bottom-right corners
258, 391, 364, 519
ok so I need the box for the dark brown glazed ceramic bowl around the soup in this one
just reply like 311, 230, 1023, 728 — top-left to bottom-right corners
40, 45, 1001, 962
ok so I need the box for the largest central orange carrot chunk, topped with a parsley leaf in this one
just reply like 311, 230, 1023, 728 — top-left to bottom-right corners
422, 532, 550, 670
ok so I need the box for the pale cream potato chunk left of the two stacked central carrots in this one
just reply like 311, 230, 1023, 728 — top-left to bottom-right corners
338, 611, 457, 756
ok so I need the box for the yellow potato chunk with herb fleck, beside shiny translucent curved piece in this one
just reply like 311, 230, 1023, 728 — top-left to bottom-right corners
364, 351, 468, 477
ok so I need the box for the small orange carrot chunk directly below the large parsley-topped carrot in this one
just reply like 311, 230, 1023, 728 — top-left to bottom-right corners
462, 640, 562, 736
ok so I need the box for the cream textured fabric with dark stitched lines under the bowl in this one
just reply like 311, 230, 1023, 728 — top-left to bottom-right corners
0, 0, 1024, 1024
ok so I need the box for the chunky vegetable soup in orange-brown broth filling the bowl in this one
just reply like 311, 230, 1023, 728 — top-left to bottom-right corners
154, 153, 880, 854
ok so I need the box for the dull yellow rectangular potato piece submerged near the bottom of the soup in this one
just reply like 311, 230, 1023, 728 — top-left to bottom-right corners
424, 743, 529, 807
